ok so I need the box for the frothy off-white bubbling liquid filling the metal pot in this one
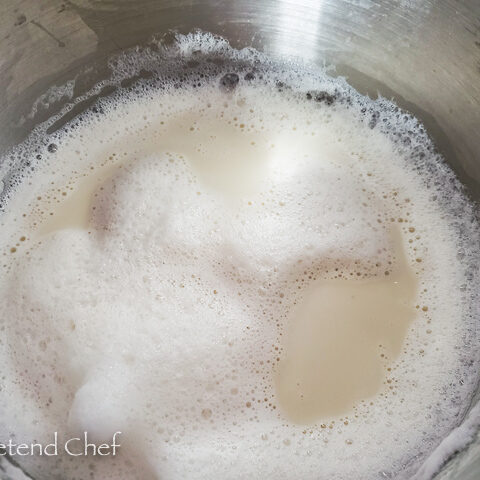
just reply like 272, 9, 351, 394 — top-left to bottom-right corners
0, 34, 478, 479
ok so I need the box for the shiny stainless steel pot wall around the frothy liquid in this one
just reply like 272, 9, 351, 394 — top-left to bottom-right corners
0, 0, 480, 479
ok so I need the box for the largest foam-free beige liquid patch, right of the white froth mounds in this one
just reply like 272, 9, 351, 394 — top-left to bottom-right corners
275, 232, 417, 424
